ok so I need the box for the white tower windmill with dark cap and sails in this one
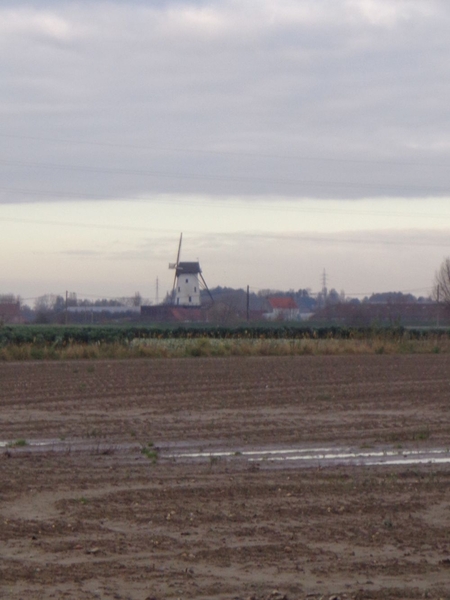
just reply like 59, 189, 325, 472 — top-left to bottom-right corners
169, 233, 214, 307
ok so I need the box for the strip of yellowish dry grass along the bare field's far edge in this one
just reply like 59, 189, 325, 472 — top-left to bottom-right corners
0, 336, 450, 361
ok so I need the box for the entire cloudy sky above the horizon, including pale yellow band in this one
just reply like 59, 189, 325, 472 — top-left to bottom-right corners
0, 0, 450, 304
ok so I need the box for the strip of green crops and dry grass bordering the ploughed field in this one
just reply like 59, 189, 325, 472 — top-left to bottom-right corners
0, 324, 450, 360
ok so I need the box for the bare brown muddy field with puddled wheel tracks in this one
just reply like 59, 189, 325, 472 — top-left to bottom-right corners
0, 355, 450, 600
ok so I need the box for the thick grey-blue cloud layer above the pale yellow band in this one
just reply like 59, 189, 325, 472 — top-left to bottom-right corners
0, 0, 450, 202
